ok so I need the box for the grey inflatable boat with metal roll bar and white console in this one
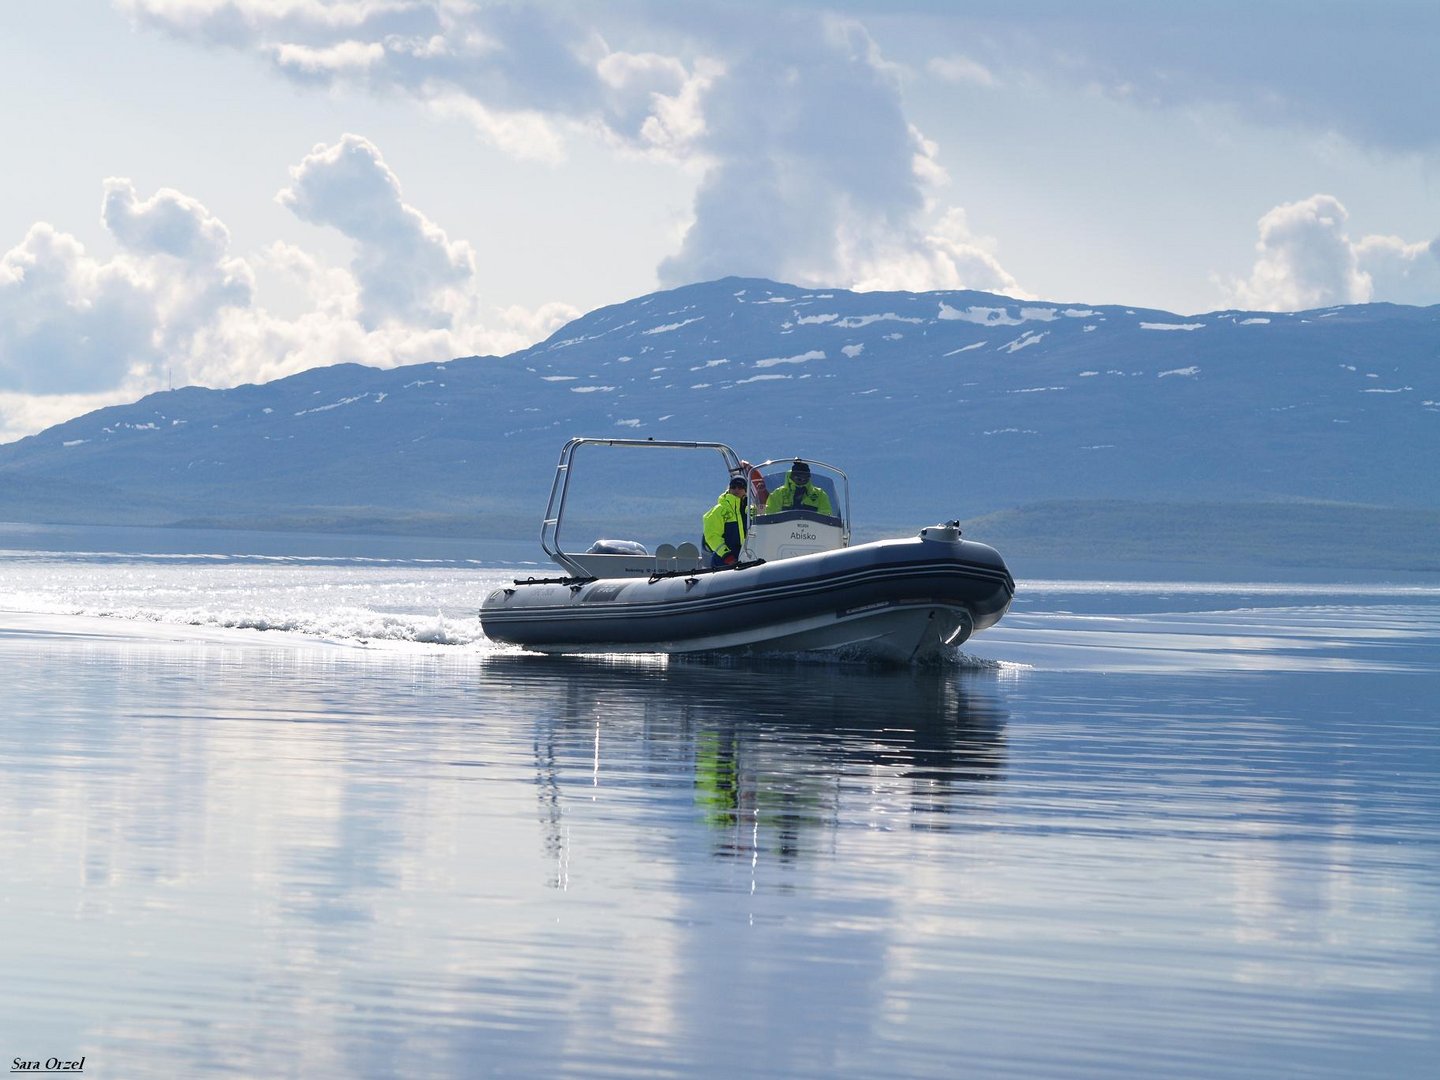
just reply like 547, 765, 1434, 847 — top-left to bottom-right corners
480, 439, 1015, 664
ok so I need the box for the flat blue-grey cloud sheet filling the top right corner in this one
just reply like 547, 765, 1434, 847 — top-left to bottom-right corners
910, 0, 1440, 154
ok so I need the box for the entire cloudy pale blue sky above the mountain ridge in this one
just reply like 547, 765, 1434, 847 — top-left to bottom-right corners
0, 0, 1440, 439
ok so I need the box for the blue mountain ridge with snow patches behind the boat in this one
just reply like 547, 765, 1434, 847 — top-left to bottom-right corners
0, 278, 1440, 570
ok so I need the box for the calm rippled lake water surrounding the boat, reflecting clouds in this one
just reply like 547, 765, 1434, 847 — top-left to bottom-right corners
0, 527, 1440, 1080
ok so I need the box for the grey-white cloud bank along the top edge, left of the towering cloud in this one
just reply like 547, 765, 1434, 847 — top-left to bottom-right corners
118, 0, 704, 158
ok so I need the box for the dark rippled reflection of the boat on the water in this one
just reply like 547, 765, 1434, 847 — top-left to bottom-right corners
487, 657, 1005, 865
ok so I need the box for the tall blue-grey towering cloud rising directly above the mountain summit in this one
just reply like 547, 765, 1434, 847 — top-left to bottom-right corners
660, 17, 1018, 292
